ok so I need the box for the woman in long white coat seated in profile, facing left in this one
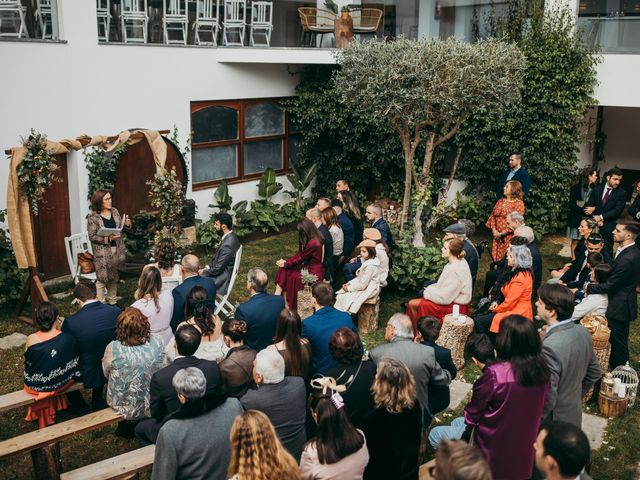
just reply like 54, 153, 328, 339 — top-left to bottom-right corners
334, 240, 381, 313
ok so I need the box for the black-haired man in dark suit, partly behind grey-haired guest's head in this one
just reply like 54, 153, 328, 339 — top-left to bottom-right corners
135, 325, 221, 447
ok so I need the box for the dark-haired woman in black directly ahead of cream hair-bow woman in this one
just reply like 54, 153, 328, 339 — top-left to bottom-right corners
327, 327, 376, 428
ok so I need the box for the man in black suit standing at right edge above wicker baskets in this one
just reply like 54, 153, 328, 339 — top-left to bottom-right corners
585, 221, 640, 369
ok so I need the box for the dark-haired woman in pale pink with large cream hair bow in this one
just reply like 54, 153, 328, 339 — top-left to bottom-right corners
300, 386, 369, 480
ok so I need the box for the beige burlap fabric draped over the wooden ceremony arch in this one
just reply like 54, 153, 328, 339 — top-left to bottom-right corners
7, 130, 167, 268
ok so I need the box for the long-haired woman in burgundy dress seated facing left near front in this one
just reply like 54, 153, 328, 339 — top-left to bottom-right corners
275, 218, 324, 311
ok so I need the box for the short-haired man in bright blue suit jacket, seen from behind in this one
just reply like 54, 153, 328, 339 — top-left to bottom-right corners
302, 282, 358, 374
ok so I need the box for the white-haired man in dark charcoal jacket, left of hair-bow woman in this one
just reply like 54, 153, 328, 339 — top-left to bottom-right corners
240, 349, 307, 461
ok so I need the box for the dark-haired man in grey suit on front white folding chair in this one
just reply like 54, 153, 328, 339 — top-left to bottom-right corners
200, 213, 240, 295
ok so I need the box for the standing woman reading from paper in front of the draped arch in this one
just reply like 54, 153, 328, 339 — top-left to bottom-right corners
87, 190, 130, 305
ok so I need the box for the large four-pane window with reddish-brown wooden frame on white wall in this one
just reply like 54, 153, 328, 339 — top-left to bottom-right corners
191, 99, 298, 190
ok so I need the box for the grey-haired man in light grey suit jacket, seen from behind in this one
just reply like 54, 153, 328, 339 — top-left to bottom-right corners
369, 313, 451, 425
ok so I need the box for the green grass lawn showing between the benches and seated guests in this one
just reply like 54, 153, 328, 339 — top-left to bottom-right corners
0, 232, 640, 480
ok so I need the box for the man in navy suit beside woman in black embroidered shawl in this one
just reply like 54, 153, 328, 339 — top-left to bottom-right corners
62, 280, 122, 411
